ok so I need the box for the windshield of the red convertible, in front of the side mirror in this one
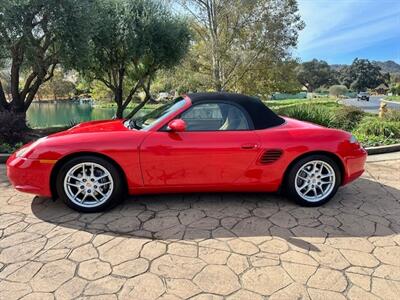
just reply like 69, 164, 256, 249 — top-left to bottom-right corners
126, 97, 185, 130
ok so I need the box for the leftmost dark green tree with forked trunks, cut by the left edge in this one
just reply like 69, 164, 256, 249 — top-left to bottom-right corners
0, 0, 91, 118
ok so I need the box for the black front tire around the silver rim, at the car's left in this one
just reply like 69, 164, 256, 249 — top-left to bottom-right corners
56, 155, 125, 213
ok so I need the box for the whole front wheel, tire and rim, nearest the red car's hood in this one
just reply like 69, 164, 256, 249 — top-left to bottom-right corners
56, 156, 123, 212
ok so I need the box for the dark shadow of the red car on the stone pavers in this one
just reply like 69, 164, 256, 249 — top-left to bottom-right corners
31, 178, 400, 251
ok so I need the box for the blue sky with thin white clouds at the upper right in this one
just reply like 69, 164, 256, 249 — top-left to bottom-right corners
293, 0, 400, 64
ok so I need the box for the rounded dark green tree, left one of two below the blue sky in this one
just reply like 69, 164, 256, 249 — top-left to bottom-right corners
297, 59, 337, 92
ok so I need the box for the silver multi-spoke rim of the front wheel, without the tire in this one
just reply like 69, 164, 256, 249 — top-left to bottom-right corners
64, 162, 114, 208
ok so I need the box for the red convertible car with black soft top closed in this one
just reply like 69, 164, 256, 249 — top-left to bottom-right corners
7, 93, 367, 212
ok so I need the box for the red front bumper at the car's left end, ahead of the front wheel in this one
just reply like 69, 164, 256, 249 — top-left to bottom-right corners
7, 154, 55, 197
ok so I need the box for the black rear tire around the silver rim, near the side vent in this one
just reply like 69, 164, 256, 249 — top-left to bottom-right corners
284, 154, 342, 206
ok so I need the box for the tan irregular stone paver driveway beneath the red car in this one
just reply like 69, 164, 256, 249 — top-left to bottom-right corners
0, 160, 400, 300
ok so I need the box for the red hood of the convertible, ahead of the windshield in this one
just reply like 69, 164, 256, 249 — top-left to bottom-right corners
51, 120, 131, 137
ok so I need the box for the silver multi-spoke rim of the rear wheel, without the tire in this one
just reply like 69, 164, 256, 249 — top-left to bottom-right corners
295, 160, 336, 202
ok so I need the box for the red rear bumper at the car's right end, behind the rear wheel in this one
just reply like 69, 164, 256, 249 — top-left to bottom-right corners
342, 147, 367, 185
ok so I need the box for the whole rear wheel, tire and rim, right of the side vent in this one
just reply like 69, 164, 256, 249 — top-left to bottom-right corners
285, 155, 341, 206
